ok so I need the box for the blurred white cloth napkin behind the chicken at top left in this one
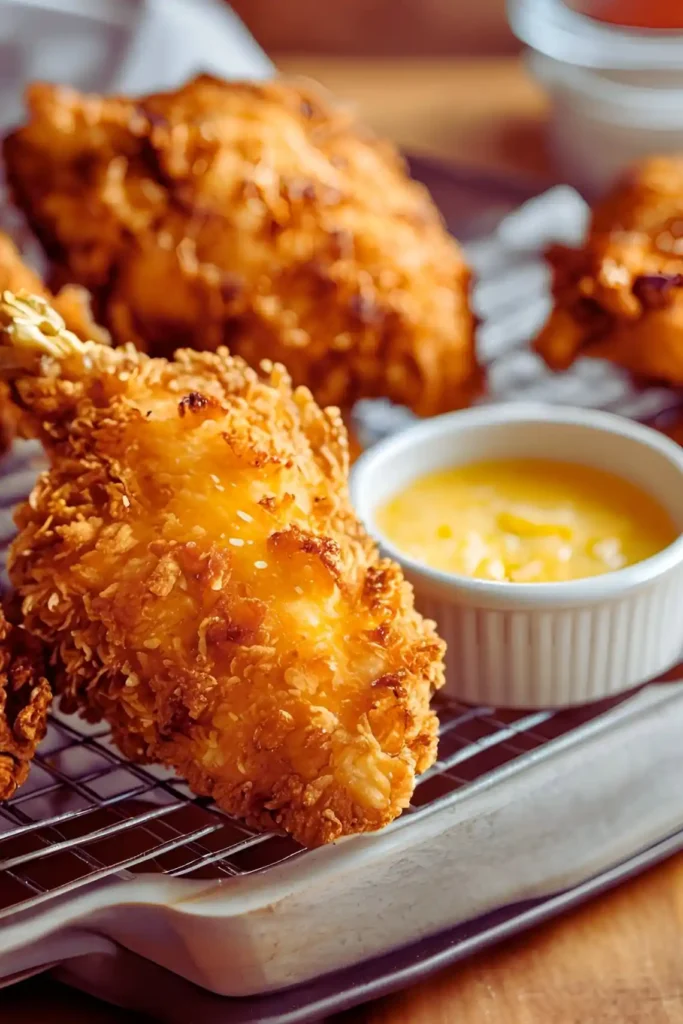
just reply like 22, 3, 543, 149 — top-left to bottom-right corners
0, 0, 272, 130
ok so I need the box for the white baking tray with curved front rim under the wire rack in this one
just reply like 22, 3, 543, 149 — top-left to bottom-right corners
0, 671, 683, 995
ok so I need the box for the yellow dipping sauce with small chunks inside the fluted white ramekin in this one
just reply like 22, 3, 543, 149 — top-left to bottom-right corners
376, 459, 680, 583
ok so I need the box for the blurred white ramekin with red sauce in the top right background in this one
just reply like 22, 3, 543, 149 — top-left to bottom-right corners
507, 0, 683, 191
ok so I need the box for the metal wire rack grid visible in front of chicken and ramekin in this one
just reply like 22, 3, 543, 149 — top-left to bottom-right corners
0, 688, 630, 921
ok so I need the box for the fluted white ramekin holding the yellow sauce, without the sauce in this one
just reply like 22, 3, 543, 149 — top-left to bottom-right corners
351, 402, 683, 708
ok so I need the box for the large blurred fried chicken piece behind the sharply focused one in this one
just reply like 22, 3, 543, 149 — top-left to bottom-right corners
4, 75, 480, 416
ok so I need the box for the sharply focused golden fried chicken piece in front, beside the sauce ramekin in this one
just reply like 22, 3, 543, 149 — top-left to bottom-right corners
0, 293, 443, 846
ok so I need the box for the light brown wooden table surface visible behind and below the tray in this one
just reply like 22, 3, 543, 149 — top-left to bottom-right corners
5, 57, 683, 1024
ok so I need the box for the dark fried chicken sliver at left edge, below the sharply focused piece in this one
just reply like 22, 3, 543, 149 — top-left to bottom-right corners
0, 607, 52, 801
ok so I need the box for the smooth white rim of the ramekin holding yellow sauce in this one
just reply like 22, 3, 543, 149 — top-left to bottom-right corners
350, 401, 683, 607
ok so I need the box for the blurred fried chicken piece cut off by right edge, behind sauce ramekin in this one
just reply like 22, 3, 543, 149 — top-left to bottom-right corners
535, 157, 683, 387
